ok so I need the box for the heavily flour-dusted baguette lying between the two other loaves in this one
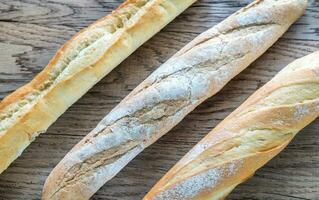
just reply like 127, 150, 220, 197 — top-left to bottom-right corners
43, 0, 306, 199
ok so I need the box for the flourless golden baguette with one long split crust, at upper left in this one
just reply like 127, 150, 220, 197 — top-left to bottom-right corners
0, 0, 195, 173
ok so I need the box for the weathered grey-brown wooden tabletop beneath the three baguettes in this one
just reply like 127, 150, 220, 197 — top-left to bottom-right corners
0, 0, 319, 200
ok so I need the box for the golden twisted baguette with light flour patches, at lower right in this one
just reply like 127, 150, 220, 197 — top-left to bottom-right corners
144, 51, 319, 200
